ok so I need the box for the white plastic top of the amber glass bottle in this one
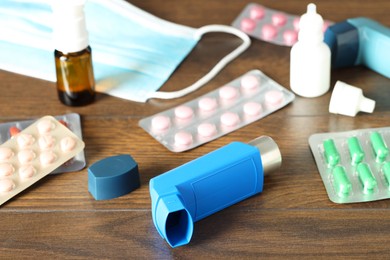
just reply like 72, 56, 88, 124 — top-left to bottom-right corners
52, 0, 89, 53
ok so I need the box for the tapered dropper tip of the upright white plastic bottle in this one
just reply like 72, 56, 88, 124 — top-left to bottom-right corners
298, 3, 324, 41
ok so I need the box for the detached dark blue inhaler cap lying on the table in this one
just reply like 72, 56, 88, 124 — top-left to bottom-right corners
88, 155, 140, 200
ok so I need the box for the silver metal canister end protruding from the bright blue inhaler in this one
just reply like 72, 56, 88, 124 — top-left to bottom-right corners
248, 136, 282, 176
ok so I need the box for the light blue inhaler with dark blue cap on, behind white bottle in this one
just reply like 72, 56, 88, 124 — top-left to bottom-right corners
324, 17, 390, 78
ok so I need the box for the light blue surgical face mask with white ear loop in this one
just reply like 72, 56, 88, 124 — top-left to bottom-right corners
0, 0, 250, 102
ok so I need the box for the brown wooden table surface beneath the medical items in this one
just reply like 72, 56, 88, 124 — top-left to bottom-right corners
0, 0, 390, 259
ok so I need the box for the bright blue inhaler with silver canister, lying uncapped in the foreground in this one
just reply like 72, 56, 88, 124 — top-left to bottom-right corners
149, 136, 282, 247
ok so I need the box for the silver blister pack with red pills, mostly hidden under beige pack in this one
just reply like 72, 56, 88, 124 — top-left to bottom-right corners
0, 113, 86, 174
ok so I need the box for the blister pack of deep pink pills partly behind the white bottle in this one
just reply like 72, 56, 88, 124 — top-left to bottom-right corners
232, 3, 331, 46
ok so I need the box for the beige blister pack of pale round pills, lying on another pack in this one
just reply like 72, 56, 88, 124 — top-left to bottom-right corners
0, 116, 84, 205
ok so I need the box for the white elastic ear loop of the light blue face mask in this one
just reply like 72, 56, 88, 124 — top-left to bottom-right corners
148, 25, 251, 99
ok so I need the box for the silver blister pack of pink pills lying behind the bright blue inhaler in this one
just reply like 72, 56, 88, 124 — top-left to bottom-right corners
139, 70, 295, 152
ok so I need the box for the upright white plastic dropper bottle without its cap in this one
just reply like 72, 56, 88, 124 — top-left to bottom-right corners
290, 4, 331, 98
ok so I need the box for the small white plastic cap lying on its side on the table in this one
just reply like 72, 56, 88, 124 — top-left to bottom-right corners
329, 81, 375, 116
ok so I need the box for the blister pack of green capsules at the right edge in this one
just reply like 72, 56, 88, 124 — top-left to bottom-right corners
309, 127, 390, 203
